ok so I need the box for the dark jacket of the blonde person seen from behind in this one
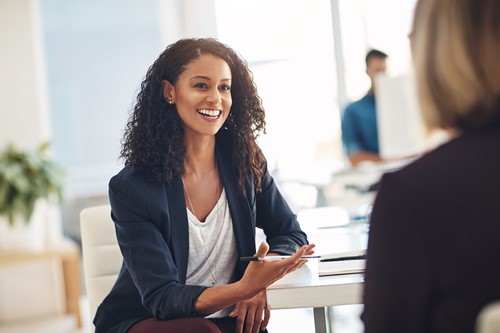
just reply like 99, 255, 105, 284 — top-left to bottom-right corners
362, 115, 500, 333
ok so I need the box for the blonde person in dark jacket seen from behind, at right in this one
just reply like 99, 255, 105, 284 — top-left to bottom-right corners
362, 0, 500, 333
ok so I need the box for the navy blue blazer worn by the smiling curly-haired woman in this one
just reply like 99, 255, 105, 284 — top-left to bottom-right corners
94, 135, 308, 333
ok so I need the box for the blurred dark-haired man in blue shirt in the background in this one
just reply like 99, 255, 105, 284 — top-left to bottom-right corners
342, 49, 387, 166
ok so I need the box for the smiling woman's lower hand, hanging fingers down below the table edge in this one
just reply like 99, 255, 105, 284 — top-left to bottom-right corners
229, 290, 271, 333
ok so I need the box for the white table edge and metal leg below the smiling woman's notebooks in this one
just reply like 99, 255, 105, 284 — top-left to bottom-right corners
267, 274, 364, 333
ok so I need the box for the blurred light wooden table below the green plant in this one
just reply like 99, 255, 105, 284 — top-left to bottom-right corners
0, 240, 82, 327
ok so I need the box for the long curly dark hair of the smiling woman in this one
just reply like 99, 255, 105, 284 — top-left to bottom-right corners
120, 38, 266, 193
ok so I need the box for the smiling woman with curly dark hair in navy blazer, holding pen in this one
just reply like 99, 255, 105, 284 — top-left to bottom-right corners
94, 39, 314, 333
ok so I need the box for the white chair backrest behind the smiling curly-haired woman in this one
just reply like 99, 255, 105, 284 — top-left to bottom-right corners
80, 205, 122, 328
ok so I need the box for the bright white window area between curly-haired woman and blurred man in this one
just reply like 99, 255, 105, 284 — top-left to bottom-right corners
215, 0, 343, 178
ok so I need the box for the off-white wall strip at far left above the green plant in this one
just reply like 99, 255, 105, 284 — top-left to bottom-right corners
0, 0, 50, 148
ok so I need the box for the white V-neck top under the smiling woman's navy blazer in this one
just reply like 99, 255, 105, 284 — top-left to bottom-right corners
186, 189, 238, 318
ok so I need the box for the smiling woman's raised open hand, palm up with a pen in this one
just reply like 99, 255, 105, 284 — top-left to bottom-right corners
240, 242, 315, 297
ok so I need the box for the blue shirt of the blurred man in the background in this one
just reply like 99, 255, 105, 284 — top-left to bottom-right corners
342, 93, 379, 155
